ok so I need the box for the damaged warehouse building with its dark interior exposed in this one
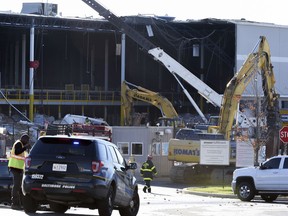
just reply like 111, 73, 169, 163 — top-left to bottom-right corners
0, 3, 288, 125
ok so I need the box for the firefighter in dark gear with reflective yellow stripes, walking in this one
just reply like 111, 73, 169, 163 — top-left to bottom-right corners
140, 155, 157, 193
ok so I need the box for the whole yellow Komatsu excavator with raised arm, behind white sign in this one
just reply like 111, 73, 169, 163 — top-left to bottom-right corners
168, 36, 281, 181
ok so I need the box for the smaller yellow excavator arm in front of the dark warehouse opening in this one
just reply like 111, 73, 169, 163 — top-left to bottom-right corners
121, 81, 179, 126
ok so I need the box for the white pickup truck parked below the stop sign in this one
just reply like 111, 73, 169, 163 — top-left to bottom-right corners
231, 155, 288, 202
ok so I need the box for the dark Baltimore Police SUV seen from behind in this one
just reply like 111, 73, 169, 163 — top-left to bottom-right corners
23, 135, 140, 216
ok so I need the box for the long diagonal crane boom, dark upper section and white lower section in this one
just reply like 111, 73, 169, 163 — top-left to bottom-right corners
82, 0, 222, 107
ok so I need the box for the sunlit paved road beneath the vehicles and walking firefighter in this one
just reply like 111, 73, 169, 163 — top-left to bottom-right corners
0, 179, 288, 216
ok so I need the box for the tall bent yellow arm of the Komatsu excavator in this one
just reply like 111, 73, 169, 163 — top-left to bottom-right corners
214, 36, 279, 142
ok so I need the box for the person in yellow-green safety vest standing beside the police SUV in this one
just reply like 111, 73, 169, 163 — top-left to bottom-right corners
8, 134, 30, 210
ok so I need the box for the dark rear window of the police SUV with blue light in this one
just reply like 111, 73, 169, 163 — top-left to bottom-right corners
31, 137, 94, 157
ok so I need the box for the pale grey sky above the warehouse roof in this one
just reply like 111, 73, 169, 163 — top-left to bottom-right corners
0, 0, 288, 25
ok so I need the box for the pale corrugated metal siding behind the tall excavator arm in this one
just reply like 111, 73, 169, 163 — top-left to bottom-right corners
236, 23, 288, 98
